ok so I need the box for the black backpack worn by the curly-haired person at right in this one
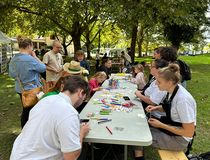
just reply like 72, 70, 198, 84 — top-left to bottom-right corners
177, 59, 191, 82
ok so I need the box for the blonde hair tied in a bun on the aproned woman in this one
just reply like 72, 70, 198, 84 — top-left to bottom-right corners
158, 64, 181, 84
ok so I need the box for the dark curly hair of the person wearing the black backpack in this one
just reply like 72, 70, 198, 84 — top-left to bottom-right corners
159, 47, 177, 62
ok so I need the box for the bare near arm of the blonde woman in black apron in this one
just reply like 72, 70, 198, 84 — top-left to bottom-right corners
148, 118, 195, 137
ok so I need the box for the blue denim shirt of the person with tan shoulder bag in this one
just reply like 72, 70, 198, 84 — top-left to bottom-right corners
9, 53, 46, 93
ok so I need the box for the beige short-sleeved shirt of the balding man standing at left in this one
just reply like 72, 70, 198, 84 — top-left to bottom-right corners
43, 50, 63, 82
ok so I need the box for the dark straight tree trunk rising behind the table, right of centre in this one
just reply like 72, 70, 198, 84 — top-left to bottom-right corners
130, 25, 138, 63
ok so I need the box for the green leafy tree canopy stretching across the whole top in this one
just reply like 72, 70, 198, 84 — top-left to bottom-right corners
0, 0, 209, 59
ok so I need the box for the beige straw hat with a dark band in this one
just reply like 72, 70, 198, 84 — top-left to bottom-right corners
63, 61, 82, 74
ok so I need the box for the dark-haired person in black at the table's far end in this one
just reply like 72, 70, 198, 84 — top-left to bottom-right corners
98, 58, 112, 79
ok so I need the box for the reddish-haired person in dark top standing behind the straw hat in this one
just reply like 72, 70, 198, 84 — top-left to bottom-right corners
75, 50, 90, 72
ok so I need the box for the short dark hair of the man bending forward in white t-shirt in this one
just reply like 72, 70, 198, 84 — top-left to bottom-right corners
61, 75, 90, 96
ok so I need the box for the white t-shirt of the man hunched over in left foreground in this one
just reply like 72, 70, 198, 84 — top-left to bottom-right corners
10, 93, 81, 160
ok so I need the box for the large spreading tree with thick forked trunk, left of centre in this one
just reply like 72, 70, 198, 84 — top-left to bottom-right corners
0, 0, 110, 54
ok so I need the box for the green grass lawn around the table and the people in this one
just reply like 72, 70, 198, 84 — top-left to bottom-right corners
0, 54, 210, 160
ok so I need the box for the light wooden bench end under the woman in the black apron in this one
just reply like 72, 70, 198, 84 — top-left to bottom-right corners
158, 150, 188, 160
